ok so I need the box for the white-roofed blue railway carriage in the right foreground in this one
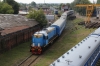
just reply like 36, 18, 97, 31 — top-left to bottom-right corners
50, 28, 100, 66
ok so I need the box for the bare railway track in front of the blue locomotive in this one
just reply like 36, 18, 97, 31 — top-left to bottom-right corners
17, 54, 40, 66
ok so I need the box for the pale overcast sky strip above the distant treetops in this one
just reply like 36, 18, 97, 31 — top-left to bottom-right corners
15, 0, 97, 3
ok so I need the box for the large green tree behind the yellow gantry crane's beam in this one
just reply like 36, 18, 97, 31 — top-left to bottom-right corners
71, 0, 91, 15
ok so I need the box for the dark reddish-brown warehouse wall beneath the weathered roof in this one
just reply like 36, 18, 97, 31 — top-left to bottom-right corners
0, 25, 40, 53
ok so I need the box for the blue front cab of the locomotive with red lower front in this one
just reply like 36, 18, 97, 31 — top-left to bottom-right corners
31, 32, 48, 54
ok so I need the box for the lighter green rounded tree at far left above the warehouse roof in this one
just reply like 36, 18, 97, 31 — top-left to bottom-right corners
0, 3, 14, 14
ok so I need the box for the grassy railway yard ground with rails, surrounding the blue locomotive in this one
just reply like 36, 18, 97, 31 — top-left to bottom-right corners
0, 13, 100, 66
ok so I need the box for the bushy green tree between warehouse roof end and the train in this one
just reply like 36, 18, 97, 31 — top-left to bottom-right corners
27, 9, 47, 27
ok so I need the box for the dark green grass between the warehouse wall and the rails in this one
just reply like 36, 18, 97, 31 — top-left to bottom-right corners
0, 42, 30, 66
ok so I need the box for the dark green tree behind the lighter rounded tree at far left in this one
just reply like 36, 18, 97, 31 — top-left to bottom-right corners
3, 0, 19, 14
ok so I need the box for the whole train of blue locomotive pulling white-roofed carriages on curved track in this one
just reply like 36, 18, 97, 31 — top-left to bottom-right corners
30, 10, 74, 54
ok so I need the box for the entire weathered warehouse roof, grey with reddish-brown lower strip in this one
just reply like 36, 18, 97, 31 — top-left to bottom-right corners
0, 14, 38, 35
